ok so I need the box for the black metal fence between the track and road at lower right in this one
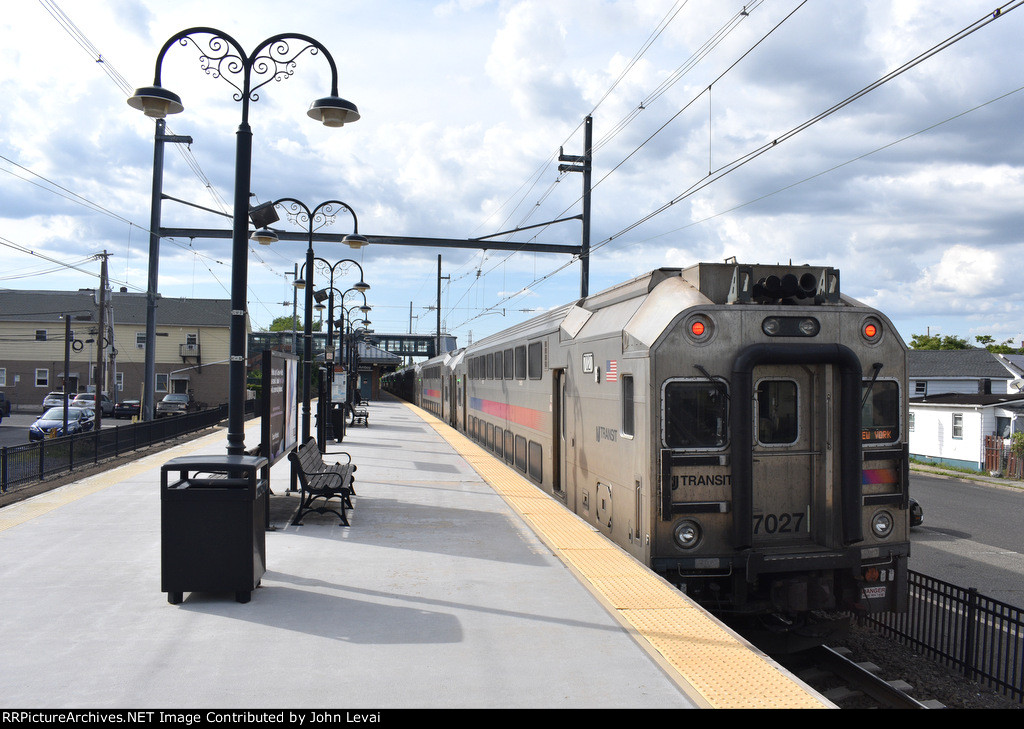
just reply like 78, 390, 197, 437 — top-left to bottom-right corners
862, 571, 1024, 702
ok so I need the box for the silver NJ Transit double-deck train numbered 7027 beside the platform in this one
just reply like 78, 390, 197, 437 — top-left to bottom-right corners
389, 263, 910, 620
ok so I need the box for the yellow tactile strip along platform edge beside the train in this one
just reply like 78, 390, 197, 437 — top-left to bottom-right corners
403, 403, 835, 709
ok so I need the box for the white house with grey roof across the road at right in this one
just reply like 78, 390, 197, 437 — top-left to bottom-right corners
907, 349, 1024, 470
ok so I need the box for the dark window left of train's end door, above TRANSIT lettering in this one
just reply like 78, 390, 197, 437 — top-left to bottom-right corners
664, 381, 729, 448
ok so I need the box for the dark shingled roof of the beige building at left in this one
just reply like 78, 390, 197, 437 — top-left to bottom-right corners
0, 289, 231, 327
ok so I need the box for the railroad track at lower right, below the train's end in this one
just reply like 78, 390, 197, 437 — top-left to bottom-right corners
779, 645, 945, 709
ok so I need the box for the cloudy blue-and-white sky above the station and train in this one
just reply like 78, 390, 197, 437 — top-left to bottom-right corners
0, 0, 1024, 344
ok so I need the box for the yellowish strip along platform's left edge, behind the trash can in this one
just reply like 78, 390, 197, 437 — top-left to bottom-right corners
0, 420, 243, 531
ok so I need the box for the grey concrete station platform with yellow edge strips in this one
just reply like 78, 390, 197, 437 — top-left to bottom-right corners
0, 400, 831, 709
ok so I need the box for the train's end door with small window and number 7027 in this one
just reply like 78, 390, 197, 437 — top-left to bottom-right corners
752, 366, 831, 547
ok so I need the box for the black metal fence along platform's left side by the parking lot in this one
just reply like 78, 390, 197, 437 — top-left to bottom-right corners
0, 402, 235, 492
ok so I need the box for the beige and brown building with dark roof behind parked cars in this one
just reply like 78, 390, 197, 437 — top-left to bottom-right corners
0, 289, 238, 412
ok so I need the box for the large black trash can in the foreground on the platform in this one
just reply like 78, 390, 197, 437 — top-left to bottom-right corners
160, 455, 269, 605
